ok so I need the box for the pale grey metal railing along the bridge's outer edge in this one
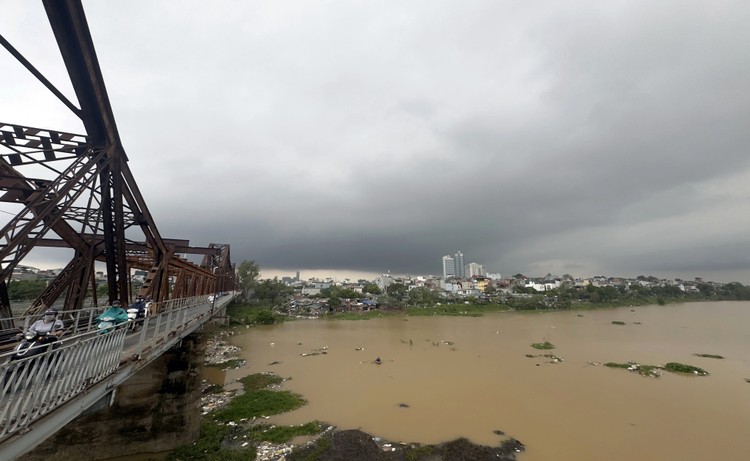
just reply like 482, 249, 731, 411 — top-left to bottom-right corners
0, 296, 232, 443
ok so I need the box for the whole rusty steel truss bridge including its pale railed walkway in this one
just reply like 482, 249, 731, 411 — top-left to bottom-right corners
0, 0, 237, 459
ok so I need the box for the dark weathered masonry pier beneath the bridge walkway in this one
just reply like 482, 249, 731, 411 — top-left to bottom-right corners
18, 333, 205, 461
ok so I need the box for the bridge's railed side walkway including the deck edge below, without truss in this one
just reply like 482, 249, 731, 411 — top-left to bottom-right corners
0, 293, 236, 460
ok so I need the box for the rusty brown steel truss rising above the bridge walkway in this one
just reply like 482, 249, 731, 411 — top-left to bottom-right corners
0, 0, 237, 318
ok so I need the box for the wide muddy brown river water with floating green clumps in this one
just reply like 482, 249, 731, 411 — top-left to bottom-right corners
225, 302, 750, 461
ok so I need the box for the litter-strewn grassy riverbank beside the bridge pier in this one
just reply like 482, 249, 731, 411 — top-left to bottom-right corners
191, 330, 525, 461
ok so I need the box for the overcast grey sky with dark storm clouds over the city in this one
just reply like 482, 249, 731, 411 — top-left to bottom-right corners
0, 0, 750, 283
